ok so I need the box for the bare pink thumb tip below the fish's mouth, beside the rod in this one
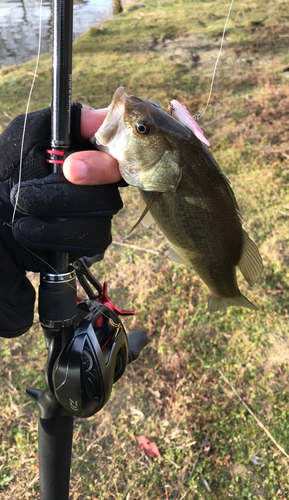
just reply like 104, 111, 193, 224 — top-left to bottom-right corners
63, 151, 121, 185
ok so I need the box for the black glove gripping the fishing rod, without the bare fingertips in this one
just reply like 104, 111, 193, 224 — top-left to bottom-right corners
0, 104, 122, 337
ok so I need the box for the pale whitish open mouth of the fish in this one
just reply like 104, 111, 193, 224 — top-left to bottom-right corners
95, 87, 128, 146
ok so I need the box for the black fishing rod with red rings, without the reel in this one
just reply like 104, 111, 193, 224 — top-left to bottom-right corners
26, 0, 77, 500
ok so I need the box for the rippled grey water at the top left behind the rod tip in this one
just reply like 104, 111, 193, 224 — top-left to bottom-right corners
0, 0, 112, 67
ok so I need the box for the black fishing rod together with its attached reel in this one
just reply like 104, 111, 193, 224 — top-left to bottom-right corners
26, 0, 148, 500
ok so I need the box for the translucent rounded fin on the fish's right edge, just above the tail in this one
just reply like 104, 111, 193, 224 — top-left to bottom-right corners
238, 229, 263, 286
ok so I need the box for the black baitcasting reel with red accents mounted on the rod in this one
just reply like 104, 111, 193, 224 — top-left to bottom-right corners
52, 259, 148, 418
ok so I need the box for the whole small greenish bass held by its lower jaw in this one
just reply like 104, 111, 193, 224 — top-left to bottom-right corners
91, 87, 263, 312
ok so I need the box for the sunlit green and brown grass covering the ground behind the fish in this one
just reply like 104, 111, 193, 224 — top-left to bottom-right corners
0, 0, 289, 500
